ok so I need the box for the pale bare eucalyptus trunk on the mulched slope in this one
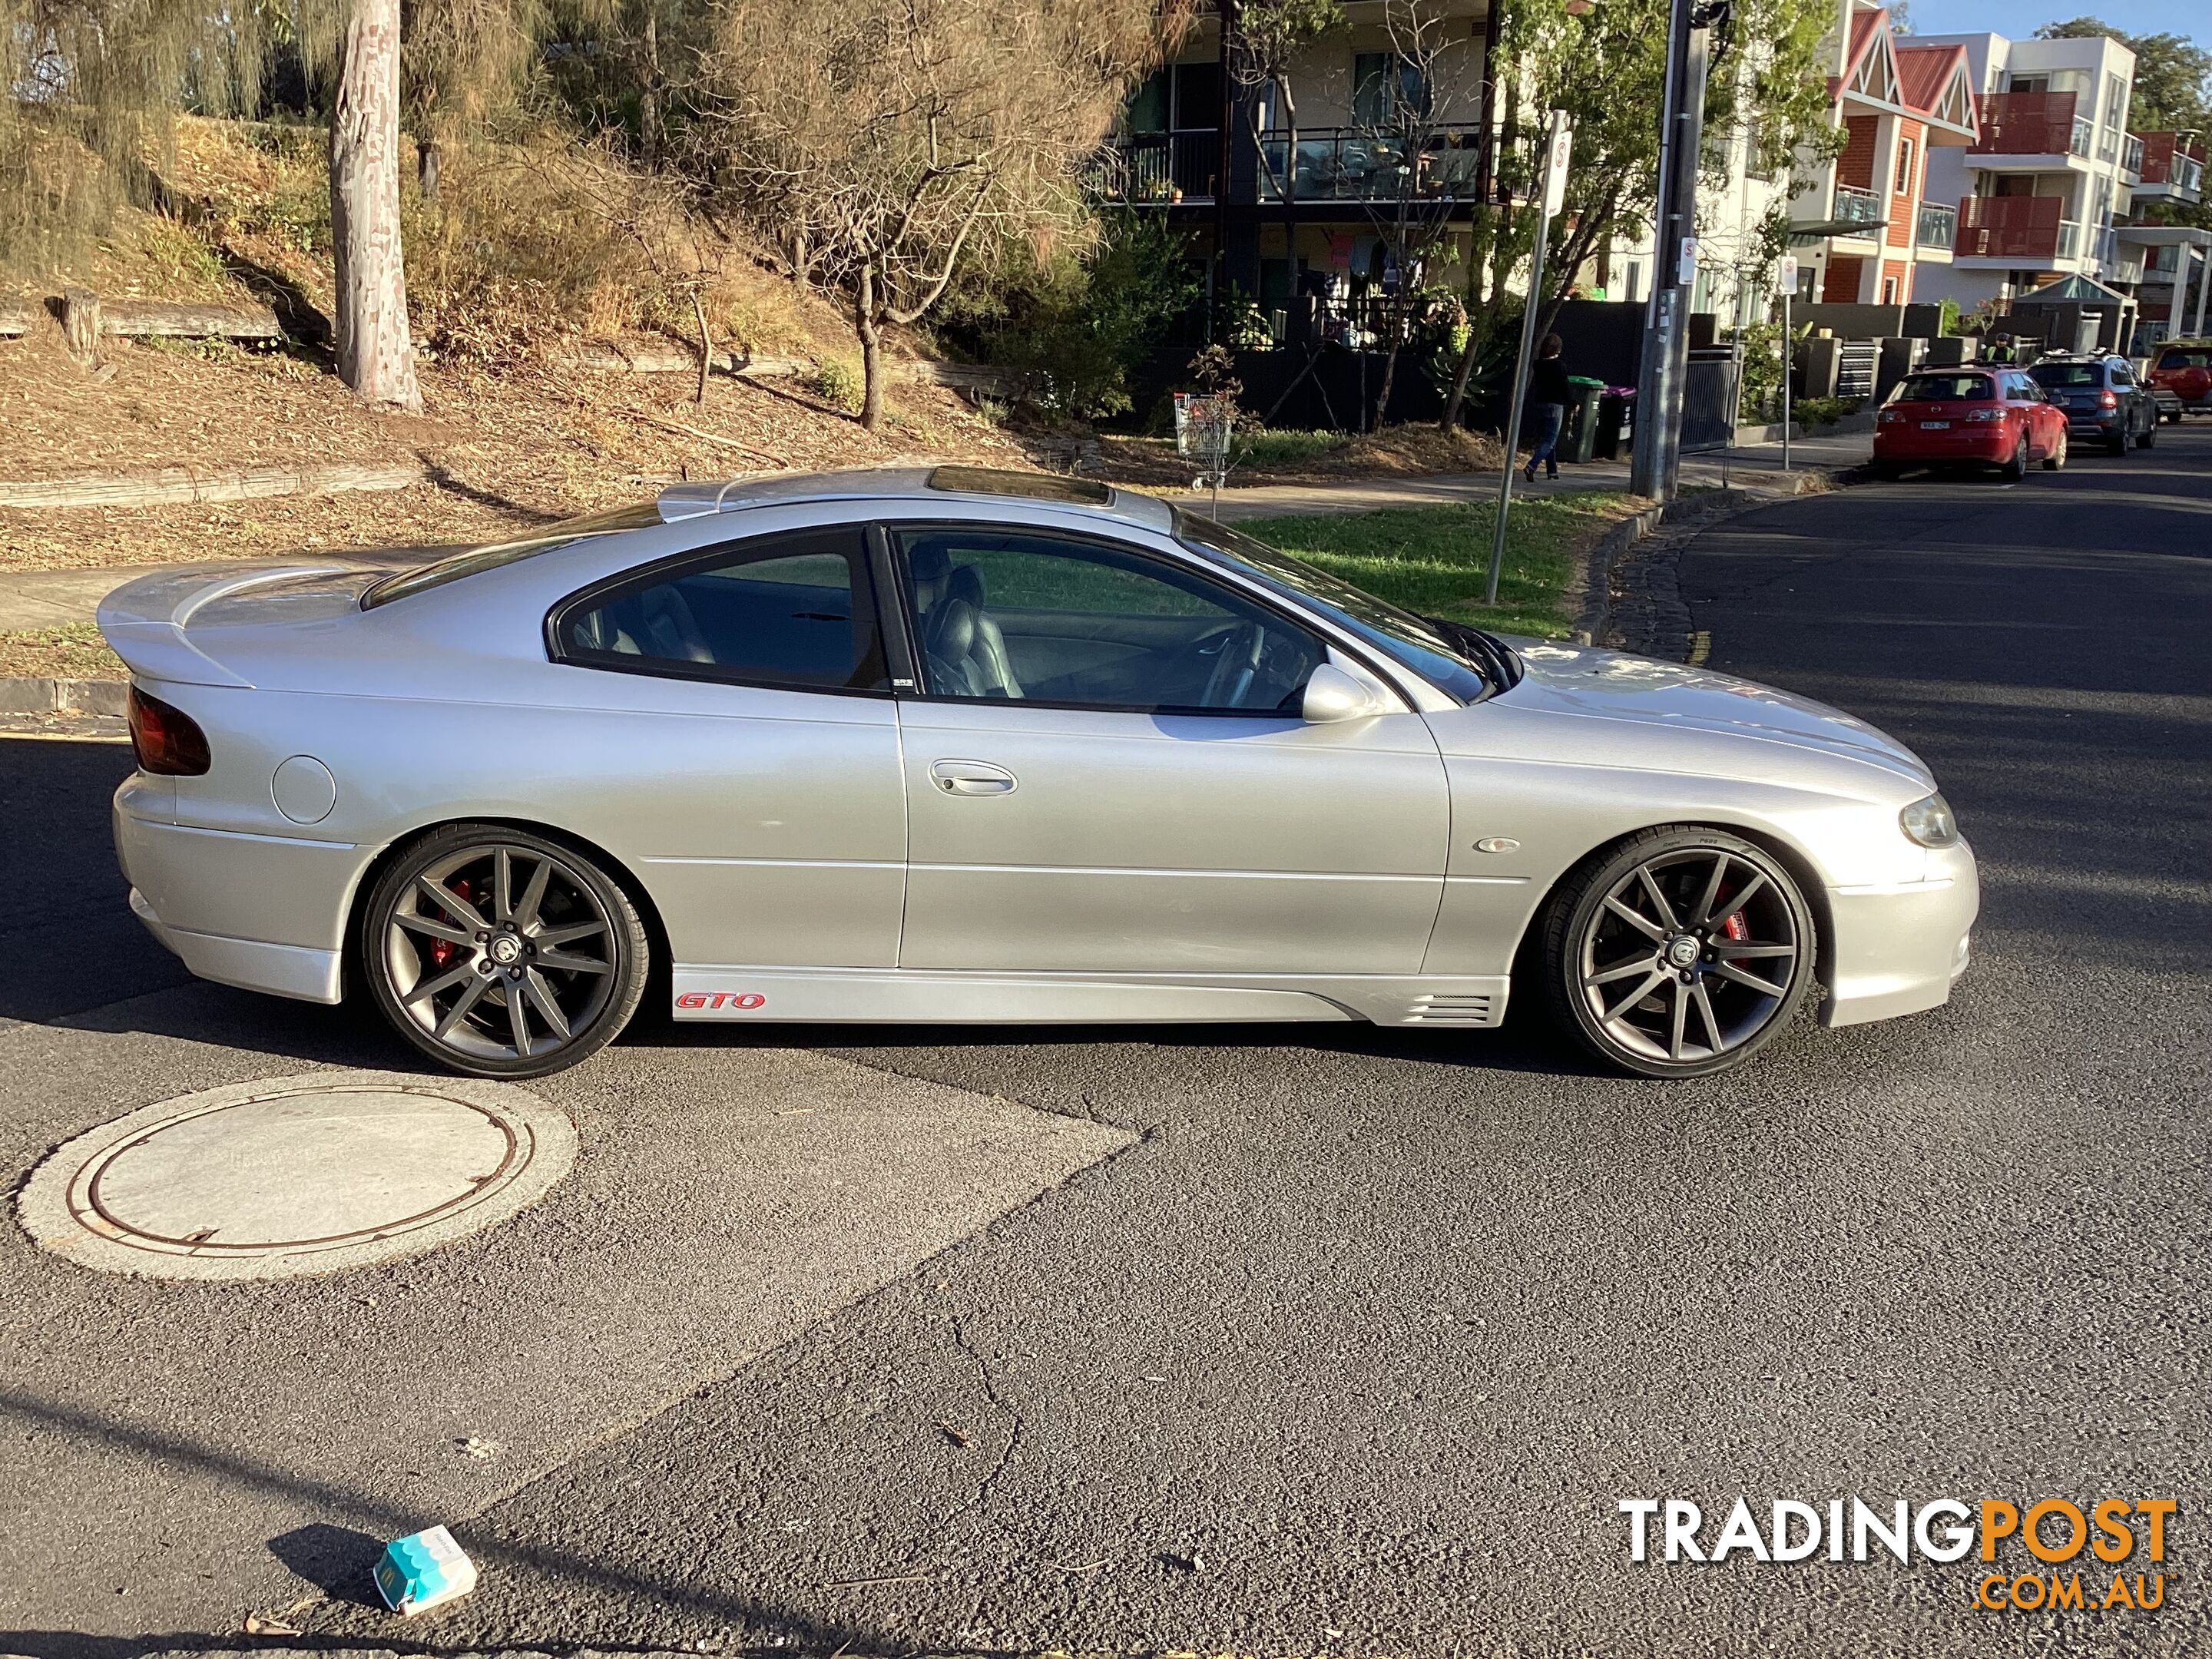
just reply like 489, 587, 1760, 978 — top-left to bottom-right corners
329, 0, 422, 409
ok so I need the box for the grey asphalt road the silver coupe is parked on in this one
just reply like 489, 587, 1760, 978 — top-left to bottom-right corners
0, 425, 2212, 1657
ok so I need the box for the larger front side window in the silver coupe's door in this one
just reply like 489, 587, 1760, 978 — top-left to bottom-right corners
898, 525, 1327, 714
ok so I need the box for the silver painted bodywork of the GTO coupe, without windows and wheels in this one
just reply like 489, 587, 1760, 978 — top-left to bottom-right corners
100, 471, 1978, 1039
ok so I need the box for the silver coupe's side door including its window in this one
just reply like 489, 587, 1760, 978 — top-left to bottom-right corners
885, 522, 1449, 973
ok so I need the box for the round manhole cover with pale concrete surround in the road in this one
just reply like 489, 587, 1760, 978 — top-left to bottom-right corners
15, 1071, 575, 1279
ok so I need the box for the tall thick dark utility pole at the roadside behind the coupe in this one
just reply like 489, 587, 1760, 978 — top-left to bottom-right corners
1628, 0, 1714, 500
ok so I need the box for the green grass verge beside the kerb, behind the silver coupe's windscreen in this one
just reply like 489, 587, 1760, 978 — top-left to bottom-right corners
1237, 491, 1634, 637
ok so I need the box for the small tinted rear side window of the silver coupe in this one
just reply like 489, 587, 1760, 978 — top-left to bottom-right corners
555, 531, 885, 690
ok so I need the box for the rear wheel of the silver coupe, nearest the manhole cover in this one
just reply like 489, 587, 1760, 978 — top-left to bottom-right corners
359, 823, 651, 1078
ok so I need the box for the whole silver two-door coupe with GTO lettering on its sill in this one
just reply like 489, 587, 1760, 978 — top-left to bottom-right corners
100, 467, 1978, 1078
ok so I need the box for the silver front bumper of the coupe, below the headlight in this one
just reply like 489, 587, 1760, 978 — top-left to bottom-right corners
1820, 840, 1982, 1026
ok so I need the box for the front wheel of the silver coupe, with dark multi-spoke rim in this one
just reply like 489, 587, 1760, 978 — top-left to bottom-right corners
1544, 825, 1816, 1078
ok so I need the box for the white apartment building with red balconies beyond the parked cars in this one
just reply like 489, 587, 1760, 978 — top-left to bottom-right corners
1918, 35, 2146, 310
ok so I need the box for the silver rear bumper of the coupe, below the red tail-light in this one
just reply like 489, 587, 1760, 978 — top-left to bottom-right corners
113, 796, 356, 1002
